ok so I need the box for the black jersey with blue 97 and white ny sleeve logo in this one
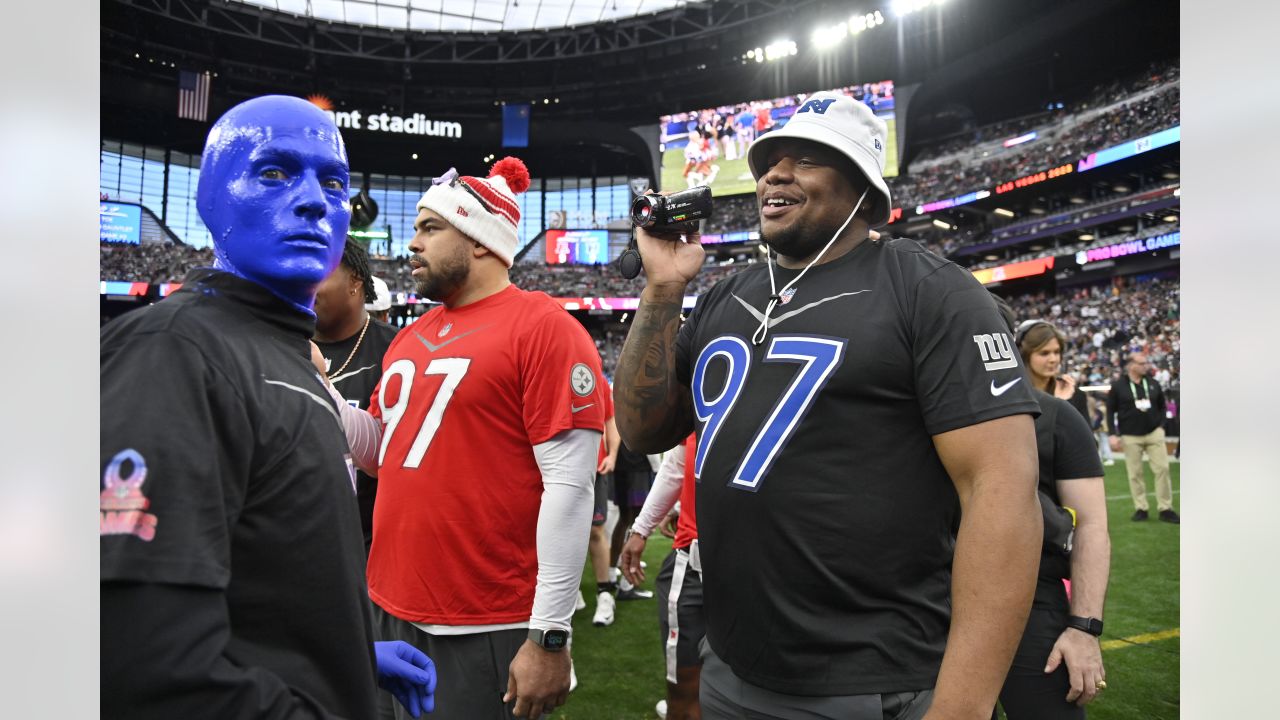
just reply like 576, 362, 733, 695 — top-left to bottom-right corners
677, 240, 1038, 696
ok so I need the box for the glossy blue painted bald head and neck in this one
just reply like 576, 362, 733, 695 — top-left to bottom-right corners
196, 95, 351, 313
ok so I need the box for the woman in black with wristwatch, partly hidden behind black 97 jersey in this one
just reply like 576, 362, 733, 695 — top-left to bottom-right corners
992, 297, 1111, 720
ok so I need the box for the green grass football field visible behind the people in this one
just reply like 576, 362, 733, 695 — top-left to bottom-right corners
550, 460, 1181, 720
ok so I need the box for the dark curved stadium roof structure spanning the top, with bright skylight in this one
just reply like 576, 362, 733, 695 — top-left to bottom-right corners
100, 0, 1178, 177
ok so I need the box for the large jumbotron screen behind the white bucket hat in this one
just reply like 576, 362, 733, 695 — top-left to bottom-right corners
658, 81, 897, 196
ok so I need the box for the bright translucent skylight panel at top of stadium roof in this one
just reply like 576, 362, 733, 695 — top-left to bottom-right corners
224, 0, 698, 32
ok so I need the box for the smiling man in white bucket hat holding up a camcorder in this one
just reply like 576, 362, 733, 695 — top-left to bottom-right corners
614, 92, 1042, 720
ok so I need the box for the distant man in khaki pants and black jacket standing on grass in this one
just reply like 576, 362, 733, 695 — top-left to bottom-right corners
1107, 352, 1179, 525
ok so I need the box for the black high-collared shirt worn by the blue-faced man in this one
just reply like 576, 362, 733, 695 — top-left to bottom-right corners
100, 269, 378, 720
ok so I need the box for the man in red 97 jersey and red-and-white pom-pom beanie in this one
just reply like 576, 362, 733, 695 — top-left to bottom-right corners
330, 158, 608, 720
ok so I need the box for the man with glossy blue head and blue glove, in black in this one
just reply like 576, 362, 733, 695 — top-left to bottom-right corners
100, 96, 435, 719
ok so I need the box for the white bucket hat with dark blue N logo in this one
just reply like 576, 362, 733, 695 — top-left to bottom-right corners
746, 91, 892, 228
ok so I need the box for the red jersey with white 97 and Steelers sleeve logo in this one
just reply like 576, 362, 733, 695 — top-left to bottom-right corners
367, 286, 608, 625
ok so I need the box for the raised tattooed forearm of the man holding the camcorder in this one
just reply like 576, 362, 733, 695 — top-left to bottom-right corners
613, 285, 694, 452
